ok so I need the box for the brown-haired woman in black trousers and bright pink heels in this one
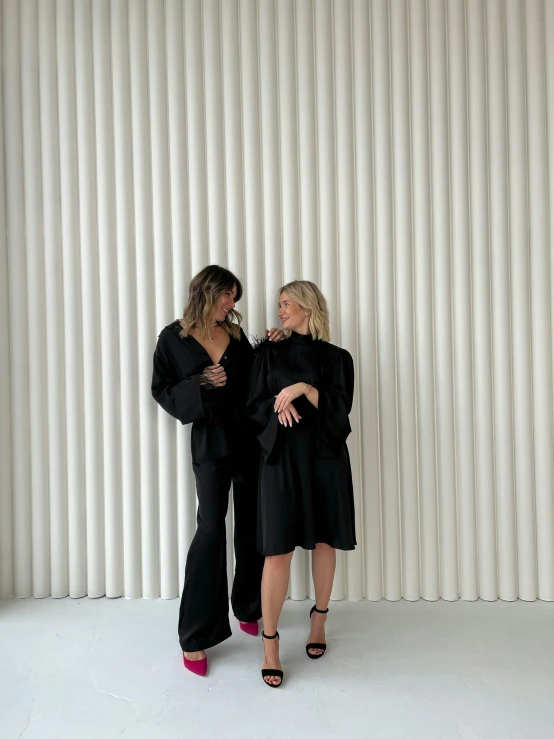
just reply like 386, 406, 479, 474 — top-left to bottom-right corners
152, 265, 283, 676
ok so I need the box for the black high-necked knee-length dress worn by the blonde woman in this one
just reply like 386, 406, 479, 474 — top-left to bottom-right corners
246, 332, 356, 556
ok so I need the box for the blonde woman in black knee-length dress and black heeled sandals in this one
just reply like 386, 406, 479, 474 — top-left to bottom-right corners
246, 281, 356, 688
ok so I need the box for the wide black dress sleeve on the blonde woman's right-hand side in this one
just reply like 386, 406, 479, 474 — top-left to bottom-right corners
317, 349, 354, 459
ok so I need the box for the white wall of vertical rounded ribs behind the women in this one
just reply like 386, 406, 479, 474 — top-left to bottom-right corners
0, 0, 554, 600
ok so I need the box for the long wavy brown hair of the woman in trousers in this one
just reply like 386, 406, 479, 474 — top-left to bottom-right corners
181, 264, 243, 339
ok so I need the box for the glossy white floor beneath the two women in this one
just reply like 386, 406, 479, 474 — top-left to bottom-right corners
0, 598, 554, 739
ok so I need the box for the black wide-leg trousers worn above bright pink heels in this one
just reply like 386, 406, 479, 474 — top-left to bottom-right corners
179, 456, 264, 652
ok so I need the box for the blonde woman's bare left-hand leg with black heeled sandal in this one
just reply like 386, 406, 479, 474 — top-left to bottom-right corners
262, 552, 293, 685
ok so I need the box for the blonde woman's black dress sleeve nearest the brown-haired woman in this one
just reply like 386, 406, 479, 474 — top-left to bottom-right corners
246, 344, 279, 459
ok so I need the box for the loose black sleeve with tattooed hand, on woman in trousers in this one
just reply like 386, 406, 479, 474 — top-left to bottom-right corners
152, 337, 206, 424
